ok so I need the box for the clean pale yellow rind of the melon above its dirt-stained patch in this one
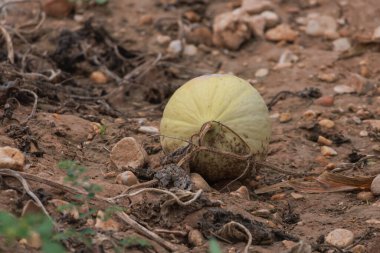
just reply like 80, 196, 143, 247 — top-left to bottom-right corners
160, 74, 271, 155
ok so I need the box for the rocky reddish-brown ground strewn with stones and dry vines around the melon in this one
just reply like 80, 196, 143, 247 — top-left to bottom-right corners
0, 0, 380, 253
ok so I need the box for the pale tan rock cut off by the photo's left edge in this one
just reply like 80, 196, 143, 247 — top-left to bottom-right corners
0, 146, 25, 171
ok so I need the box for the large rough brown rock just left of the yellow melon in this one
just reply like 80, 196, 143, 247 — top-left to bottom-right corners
110, 137, 148, 171
